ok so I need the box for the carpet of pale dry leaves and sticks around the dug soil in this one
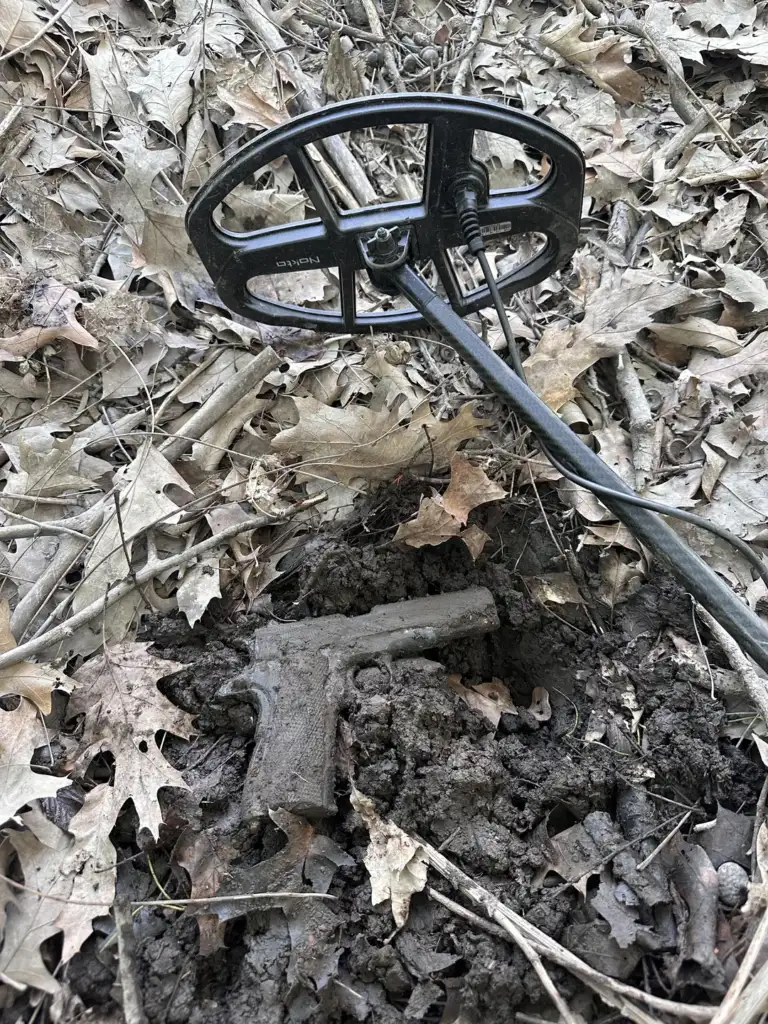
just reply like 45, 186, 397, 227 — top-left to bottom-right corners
0, 0, 768, 1019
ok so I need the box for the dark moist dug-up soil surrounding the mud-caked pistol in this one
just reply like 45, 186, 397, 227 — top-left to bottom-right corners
20, 488, 764, 1024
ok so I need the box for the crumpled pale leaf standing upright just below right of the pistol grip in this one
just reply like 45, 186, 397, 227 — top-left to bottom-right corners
349, 785, 429, 929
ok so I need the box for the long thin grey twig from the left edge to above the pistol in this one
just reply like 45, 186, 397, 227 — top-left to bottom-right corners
0, 494, 327, 669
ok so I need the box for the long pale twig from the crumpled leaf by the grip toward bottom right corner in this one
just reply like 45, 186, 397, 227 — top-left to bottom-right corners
421, 837, 715, 1021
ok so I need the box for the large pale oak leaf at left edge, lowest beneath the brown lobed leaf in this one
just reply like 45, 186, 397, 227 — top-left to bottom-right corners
0, 783, 120, 992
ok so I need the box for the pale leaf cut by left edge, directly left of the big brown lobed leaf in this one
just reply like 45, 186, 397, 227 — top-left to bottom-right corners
0, 698, 71, 825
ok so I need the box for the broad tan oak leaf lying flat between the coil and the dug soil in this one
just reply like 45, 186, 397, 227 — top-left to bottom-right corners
272, 397, 489, 483
